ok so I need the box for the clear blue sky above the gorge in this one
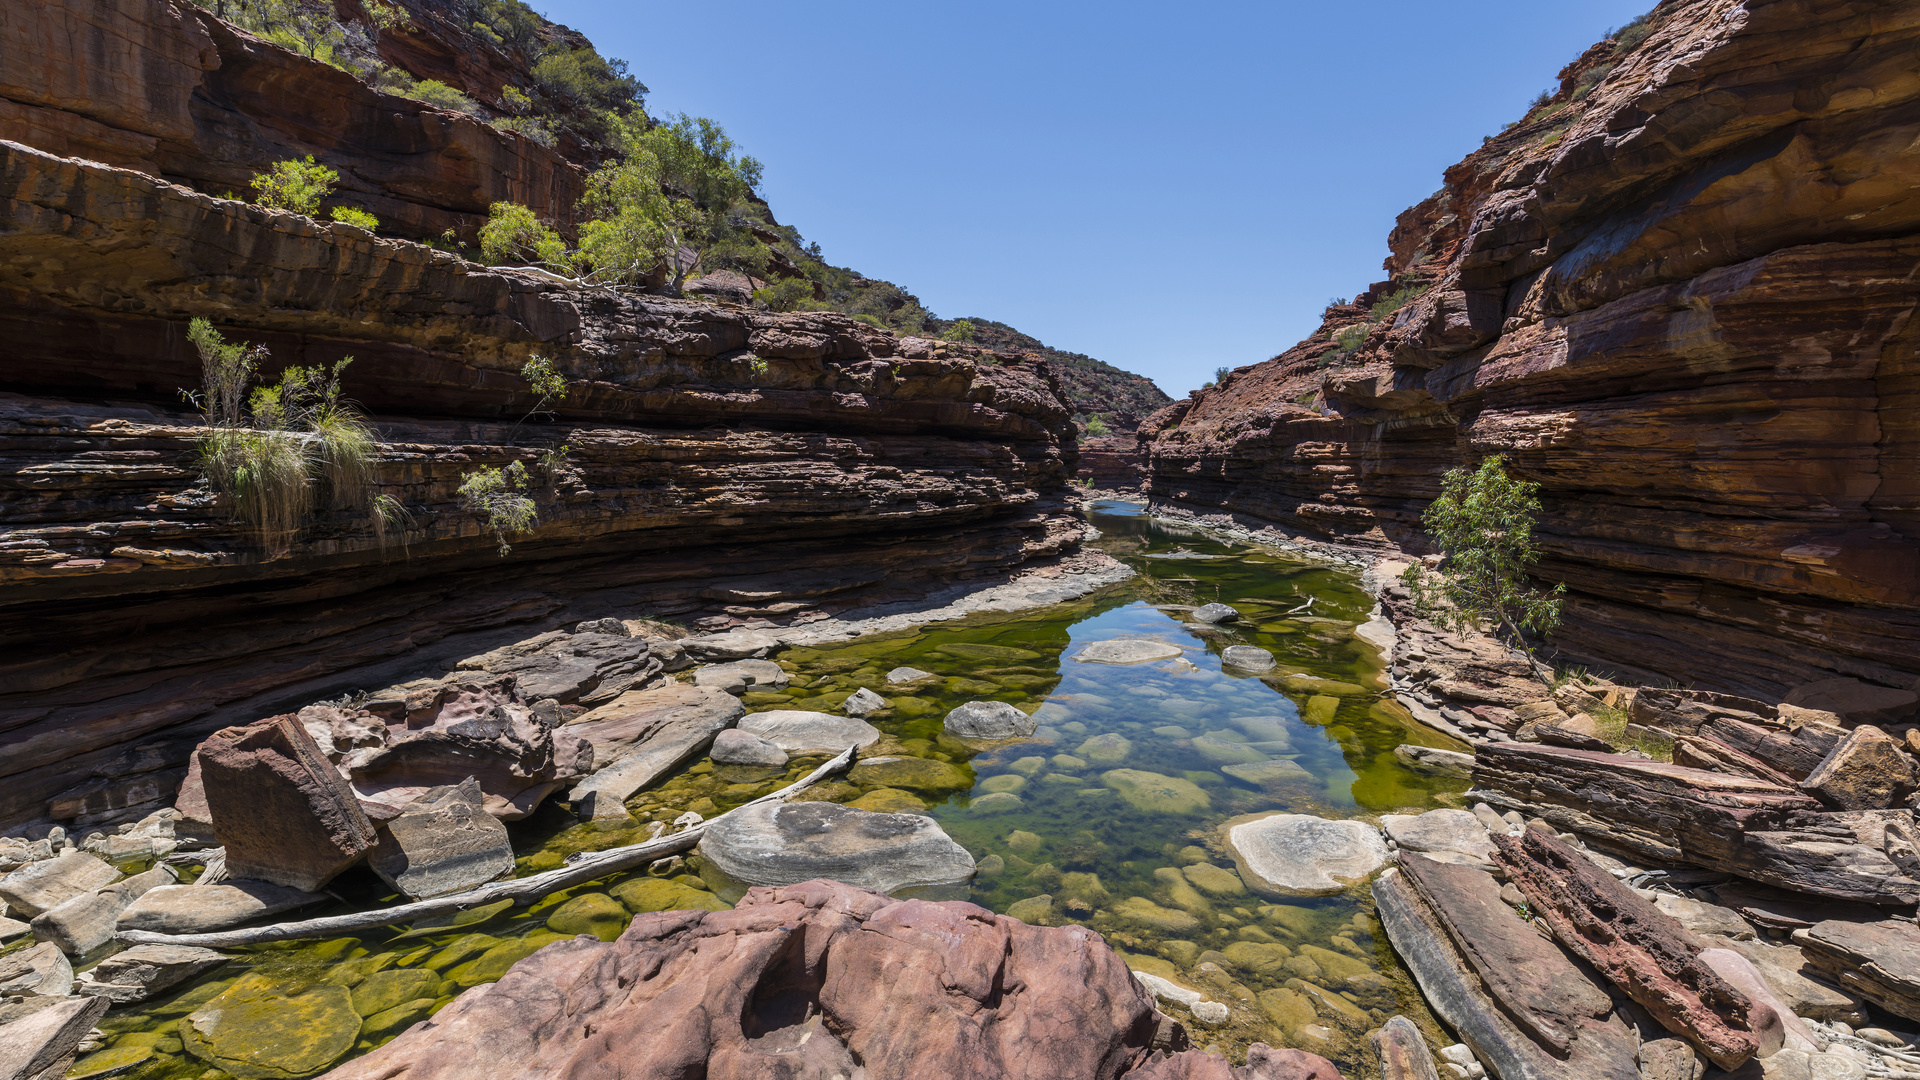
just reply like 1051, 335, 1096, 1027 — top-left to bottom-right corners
532, 0, 1653, 396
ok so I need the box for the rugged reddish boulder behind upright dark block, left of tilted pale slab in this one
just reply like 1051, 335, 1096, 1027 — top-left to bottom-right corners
344, 672, 591, 821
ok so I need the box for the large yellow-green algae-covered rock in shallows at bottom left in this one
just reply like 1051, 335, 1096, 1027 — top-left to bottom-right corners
180, 974, 361, 1080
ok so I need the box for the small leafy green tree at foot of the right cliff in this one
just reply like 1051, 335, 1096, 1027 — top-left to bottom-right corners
1400, 454, 1567, 676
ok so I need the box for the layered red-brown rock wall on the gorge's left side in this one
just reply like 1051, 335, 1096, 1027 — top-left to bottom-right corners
0, 0, 1083, 826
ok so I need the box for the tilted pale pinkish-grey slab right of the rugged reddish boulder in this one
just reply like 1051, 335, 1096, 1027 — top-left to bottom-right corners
561, 682, 741, 819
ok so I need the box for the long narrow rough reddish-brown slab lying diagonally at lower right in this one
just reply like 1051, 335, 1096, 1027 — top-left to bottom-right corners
1494, 824, 1784, 1072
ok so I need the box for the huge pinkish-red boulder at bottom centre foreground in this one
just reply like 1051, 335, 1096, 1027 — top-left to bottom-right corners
328, 882, 1290, 1080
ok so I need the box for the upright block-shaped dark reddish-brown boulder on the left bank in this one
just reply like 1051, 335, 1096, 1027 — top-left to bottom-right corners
194, 717, 374, 892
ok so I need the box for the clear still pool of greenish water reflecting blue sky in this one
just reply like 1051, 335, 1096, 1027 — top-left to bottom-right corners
63, 502, 1465, 1080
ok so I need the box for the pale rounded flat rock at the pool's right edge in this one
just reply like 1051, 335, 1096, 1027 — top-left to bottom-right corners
1225, 813, 1392, 896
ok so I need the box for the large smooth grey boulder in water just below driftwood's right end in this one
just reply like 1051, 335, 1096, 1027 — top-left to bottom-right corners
701, 801, 973, 892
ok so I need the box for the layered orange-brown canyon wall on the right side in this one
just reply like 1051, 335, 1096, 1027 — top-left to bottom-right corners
1140, 0, 1920, 700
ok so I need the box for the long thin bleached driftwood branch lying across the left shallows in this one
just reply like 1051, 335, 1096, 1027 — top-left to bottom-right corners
113, 748, 854, 949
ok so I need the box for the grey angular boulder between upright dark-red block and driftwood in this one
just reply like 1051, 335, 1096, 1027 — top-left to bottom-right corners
367, 776, 513, 899
